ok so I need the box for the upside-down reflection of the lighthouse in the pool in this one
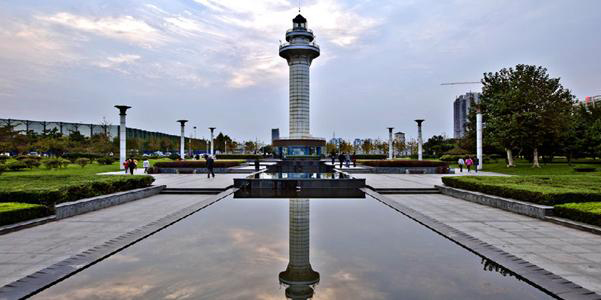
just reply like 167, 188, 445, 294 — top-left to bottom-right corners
279, 199, 319, 299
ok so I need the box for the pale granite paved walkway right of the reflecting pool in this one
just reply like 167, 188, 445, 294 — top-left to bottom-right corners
387, 195, 601, 294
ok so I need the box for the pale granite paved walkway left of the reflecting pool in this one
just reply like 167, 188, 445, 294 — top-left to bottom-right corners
0, 195, 211, 287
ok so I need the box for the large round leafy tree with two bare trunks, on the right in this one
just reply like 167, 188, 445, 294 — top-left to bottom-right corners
480, 65, 574, 167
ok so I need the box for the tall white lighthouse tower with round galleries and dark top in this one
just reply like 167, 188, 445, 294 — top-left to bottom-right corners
273, 14, 325, 156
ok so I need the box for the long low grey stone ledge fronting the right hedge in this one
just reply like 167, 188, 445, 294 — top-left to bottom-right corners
435, 185, 553, 220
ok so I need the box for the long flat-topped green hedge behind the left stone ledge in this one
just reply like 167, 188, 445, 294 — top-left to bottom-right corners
0, 175, 154, 207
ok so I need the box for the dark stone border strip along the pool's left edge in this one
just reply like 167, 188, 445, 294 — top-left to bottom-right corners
0, 189, 236, 300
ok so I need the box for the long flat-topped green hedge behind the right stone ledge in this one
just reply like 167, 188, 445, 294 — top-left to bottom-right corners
442, 175, 601, 205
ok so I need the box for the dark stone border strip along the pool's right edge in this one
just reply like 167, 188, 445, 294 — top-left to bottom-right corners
362, 189, 601, 300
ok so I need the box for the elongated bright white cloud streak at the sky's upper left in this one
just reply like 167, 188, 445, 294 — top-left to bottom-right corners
38, 12, 167, 47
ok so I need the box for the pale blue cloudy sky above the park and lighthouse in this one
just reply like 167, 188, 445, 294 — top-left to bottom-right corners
0, 0, 601, 141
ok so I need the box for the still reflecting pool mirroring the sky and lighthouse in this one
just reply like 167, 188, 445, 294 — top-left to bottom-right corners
34, 196, 550, 300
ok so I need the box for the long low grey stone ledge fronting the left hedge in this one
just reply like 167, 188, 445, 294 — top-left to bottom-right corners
55, 185, 165, 220
